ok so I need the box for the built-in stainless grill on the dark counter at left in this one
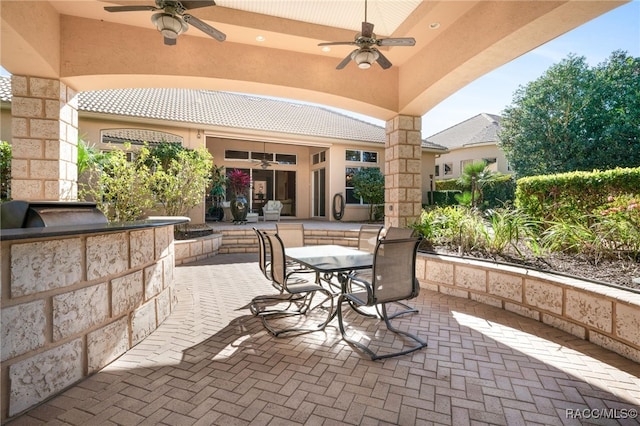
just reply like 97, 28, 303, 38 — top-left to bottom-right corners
0, 200, 108, 229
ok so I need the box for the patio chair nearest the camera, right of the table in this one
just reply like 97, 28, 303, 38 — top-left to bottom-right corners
337, 238, 427, 360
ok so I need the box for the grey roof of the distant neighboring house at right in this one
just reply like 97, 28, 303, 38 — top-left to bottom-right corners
427, 113, 502, 149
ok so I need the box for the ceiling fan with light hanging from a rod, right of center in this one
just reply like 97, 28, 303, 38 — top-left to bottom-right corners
318, 0, 416, 70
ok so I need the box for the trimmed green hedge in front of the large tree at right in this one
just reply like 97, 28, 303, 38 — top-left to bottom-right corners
516, 167, 640, 220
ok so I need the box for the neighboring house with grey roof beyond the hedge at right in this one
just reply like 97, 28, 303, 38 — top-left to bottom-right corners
427, 113, 511, 180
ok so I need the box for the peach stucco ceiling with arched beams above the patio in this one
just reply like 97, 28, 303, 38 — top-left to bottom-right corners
0, 0, 626, 120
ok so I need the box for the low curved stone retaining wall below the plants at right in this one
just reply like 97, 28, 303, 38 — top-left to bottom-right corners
416, 253, 640, 362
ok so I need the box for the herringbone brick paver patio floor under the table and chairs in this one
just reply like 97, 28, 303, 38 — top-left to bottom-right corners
13, 254, 640, 426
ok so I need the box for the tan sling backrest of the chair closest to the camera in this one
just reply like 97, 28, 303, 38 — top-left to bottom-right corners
369, 238, 420, 304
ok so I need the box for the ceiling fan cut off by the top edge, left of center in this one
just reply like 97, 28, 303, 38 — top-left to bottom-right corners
104, 0, 227, 46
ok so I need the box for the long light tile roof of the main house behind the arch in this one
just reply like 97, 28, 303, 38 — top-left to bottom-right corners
0, 77, 444, 150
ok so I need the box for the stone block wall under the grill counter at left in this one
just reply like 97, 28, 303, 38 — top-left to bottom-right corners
0, 226, 176, 423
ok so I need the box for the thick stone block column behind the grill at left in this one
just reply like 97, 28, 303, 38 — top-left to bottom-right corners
11, 75, 78, 201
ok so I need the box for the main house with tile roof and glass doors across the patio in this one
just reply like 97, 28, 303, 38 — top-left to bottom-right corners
0, 77, 446, 223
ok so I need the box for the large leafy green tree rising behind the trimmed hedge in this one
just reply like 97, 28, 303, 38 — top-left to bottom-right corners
499, 51, 640, 176
